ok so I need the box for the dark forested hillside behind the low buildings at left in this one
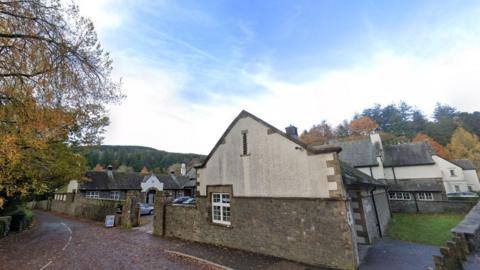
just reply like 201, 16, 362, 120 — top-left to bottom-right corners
83, 145, 204, 172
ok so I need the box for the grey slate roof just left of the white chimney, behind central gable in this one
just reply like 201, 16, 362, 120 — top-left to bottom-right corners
312, 139, 378, 167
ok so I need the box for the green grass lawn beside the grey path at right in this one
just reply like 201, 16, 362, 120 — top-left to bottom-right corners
387, 213, 465, 246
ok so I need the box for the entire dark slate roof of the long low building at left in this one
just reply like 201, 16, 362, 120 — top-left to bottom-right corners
79, 171, 196, 190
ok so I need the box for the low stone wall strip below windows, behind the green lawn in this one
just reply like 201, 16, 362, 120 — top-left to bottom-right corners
390, 199, 475, 213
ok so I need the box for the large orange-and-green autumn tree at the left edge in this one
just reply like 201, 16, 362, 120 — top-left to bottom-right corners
0, 0, 122, 208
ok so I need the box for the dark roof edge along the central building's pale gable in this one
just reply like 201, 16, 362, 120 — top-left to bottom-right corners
196, 110, 341, 168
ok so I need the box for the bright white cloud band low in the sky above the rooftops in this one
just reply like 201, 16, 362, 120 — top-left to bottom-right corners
76, 0, 480, 154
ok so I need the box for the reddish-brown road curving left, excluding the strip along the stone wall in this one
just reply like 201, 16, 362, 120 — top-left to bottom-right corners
0, 212, 215, 270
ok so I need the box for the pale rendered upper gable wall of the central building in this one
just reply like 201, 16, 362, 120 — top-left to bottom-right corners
198, 117, 339, 198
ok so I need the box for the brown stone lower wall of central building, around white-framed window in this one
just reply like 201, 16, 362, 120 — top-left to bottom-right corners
163, 196, 357, 269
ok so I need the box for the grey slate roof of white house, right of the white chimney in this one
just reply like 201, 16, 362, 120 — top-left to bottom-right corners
383, 141, 435, 167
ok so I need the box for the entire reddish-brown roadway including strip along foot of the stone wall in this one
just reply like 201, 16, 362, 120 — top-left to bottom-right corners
0, 211, 324, 270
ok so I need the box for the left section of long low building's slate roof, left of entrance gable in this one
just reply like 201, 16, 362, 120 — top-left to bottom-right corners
79, 171, 143, 190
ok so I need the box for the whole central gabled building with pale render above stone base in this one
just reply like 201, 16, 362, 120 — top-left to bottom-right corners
161, 111, 390, 269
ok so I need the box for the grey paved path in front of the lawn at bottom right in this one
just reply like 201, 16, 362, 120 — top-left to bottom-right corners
359, 238, 440, 270
